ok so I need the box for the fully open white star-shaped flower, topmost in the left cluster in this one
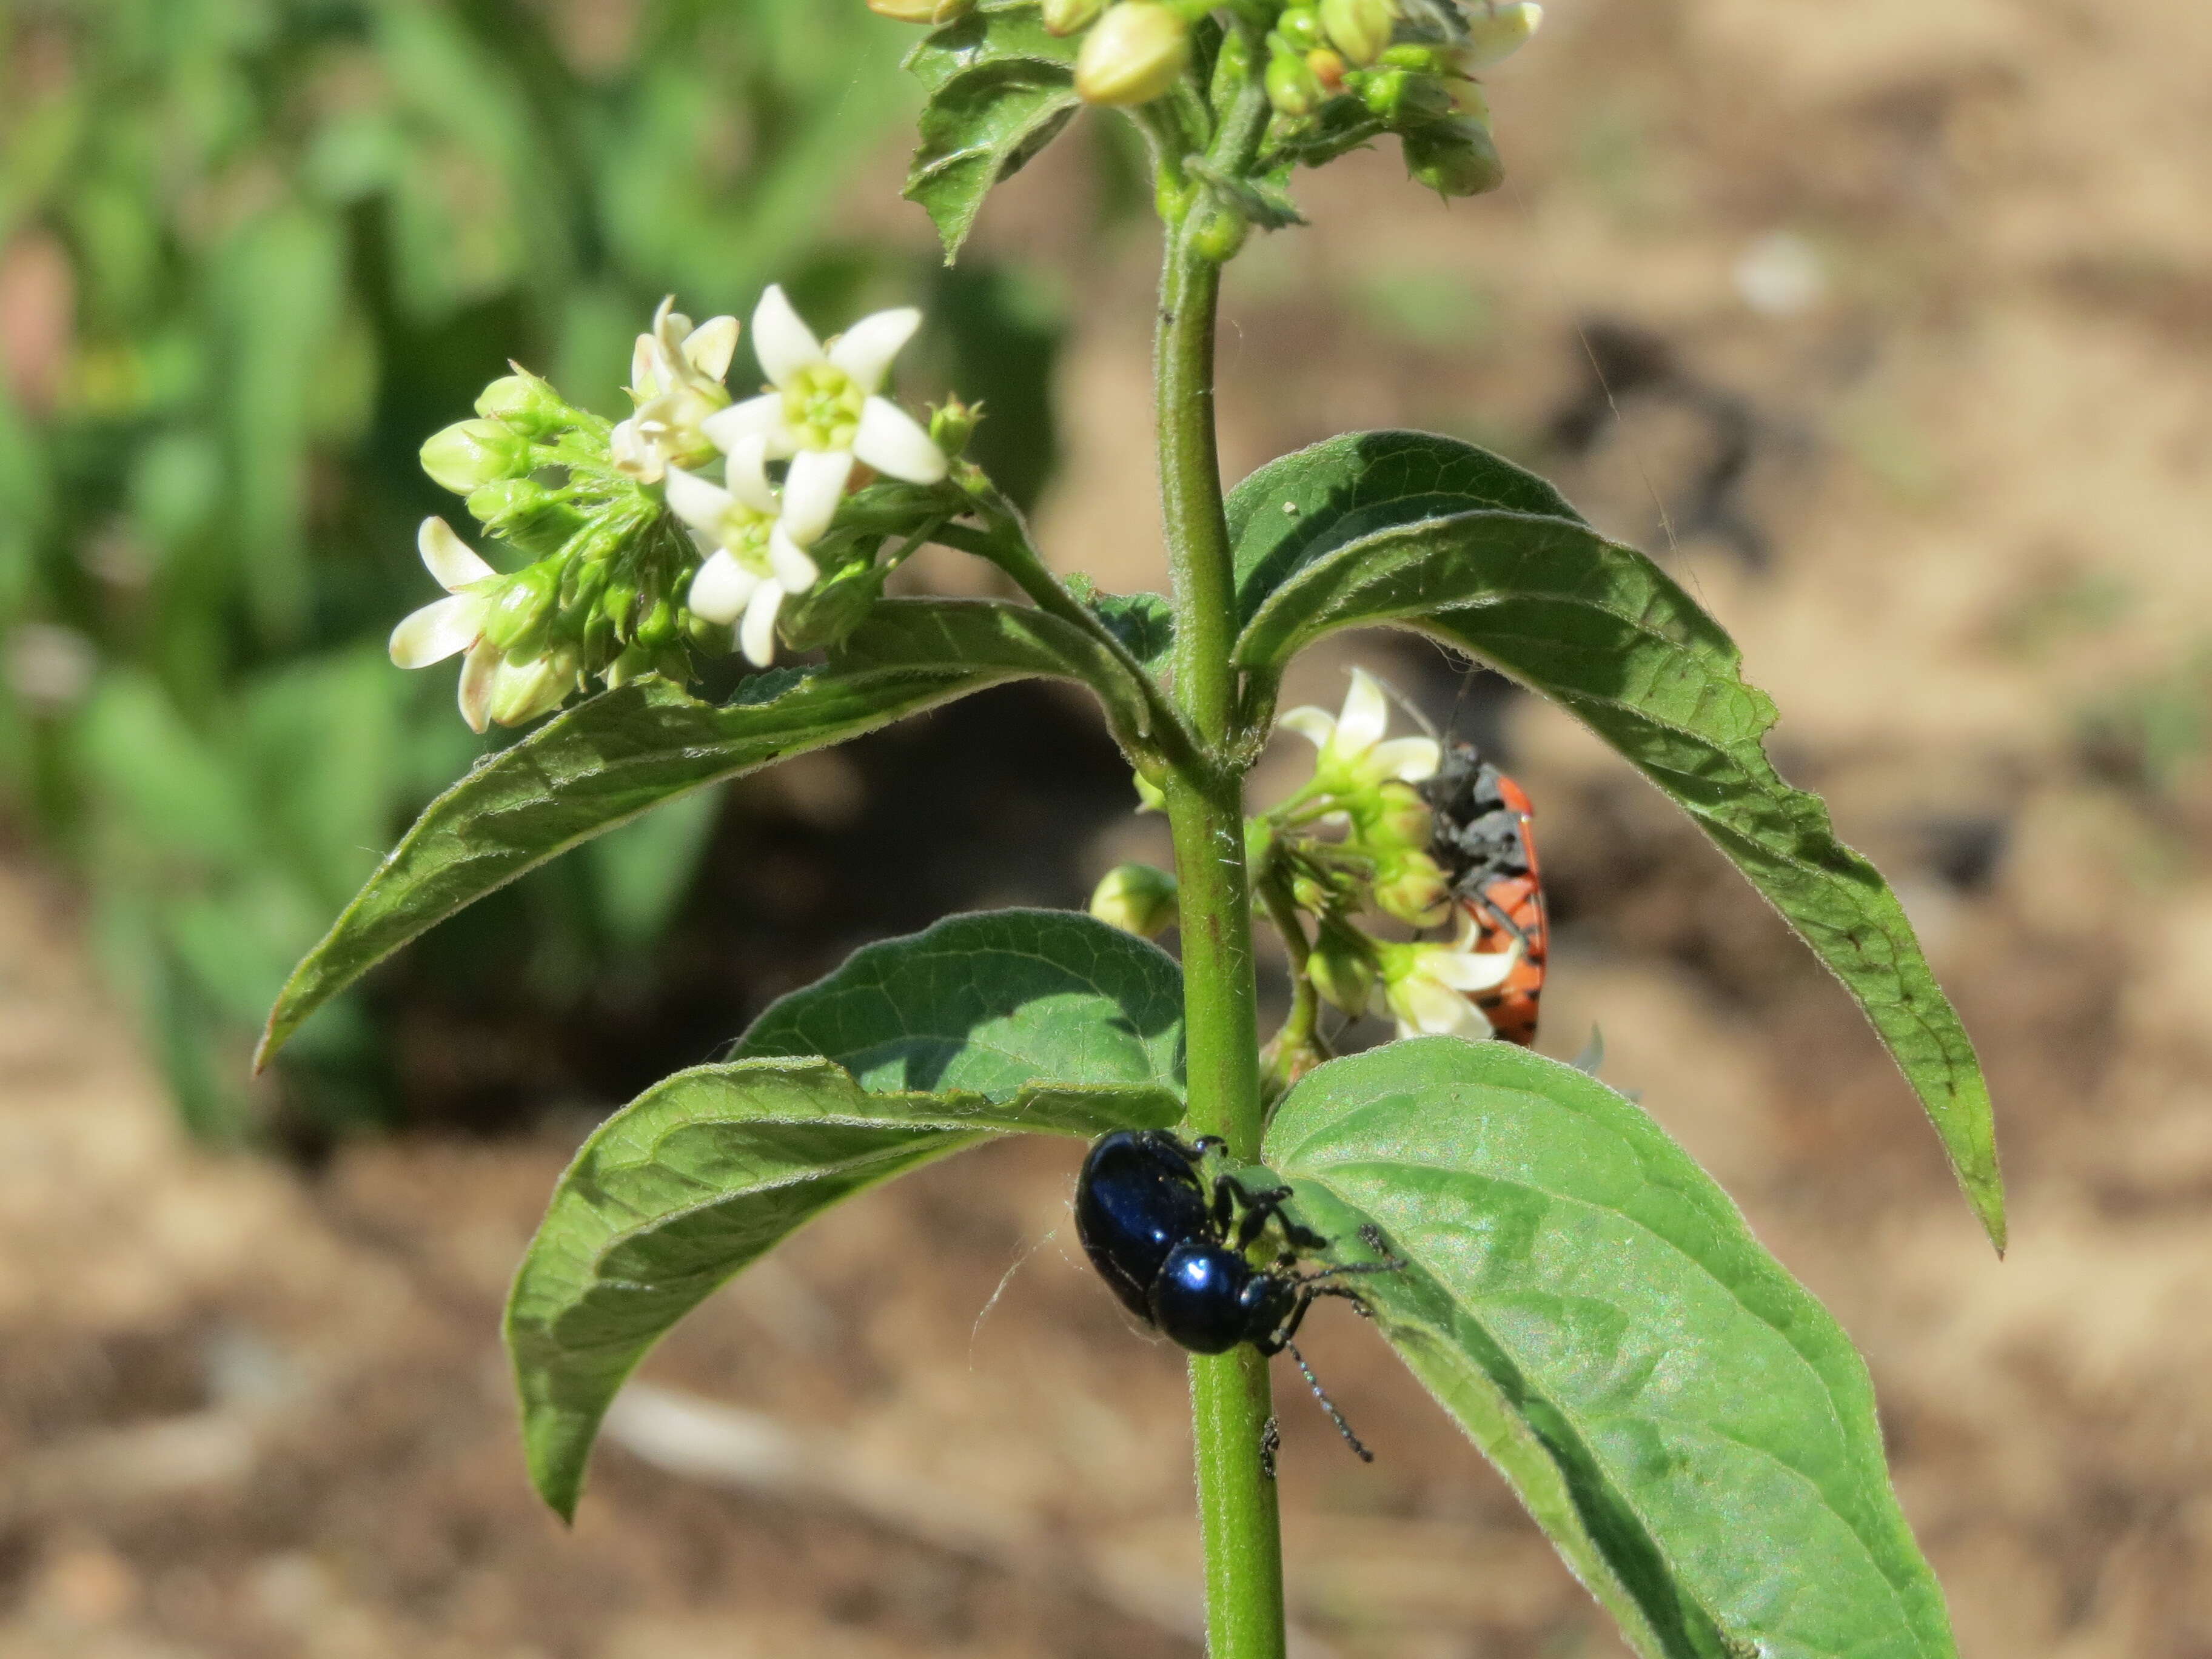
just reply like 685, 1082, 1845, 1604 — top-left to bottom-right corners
706, 286, 947, 546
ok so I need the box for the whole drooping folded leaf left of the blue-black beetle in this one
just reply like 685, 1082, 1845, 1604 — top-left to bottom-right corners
506, 911, 1184, 1515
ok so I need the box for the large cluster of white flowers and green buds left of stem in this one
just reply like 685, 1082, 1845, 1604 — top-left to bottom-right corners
392, 287, 947, 732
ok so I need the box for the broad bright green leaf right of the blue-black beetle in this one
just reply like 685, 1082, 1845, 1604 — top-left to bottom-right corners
1265, 1037, 1953, 1659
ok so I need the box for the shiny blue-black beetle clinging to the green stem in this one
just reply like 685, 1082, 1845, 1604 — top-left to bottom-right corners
1075, 1128, 1404, 1460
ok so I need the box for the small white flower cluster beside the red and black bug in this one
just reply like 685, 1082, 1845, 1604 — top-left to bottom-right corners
1261, 668, 1518, 1037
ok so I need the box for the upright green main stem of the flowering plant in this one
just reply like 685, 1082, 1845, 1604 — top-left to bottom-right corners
1153, 221, 1283, 1659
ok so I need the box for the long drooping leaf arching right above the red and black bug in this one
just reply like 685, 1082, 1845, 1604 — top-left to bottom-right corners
1236, 434, 2004, 1250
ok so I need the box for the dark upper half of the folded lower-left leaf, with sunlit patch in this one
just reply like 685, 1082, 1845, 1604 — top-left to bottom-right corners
737, 909, 1184, 1097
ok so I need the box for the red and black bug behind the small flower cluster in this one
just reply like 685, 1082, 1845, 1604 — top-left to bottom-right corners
1420, 743, 1550, 1047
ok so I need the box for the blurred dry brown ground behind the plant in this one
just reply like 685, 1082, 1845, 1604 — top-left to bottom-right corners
0, 0, 2212, 1659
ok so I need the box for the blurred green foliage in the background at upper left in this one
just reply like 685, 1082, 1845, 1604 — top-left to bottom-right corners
0, 0, 1059, 1139
